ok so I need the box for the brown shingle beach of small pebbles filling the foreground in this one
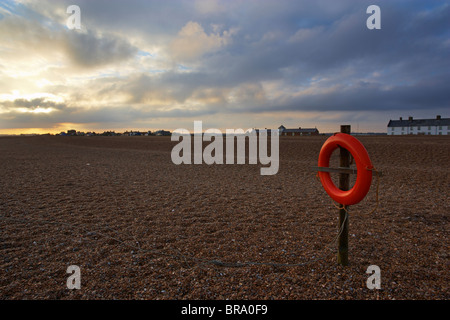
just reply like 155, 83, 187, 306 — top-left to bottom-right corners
0, 136, 450, 300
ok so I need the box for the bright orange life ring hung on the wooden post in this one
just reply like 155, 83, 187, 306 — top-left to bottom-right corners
319, 133, 373, 205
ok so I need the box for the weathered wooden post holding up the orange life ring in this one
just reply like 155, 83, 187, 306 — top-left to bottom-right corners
337, 125, 351, 266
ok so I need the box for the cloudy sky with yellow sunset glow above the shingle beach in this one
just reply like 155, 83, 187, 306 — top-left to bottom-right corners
0, 0, 450, 134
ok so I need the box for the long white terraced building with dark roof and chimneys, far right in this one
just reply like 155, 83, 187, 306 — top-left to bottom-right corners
387, 115, 450, 136
